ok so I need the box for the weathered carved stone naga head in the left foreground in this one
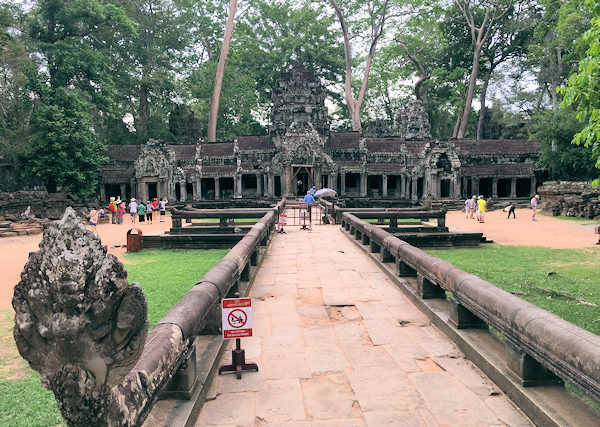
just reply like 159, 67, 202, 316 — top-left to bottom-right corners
12, 208, 148, 425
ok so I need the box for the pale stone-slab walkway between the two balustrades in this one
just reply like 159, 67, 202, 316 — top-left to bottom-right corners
196, 225, 532, 426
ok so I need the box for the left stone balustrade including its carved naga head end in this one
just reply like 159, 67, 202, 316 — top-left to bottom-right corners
13, 202, 285, 426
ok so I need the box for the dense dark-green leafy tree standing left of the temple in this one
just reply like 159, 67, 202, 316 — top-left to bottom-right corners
29, 0, 130, 196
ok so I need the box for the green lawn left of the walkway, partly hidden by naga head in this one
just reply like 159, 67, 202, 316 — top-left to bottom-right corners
0, 249, 228, 427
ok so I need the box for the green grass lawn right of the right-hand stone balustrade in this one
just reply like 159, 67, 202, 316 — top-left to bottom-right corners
427, 244, 600, 335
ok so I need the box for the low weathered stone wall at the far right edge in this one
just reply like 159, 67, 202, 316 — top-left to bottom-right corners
538, 181, 600, 219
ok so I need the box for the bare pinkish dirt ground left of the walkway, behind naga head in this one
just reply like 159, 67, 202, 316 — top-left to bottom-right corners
0, 216, 171, 310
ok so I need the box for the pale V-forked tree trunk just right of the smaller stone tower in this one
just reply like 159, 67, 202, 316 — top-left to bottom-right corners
453, 0, 514, 138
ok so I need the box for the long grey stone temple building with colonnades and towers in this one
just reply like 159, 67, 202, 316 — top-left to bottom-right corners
99, 64, 546, 201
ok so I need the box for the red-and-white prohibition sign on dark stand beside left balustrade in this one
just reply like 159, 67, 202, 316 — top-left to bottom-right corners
219, 294, 258, 380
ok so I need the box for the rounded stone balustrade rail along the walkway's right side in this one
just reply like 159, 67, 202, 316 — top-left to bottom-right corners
341, 212, 600, 403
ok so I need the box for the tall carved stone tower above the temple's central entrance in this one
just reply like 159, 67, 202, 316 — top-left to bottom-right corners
271, 63, 329, 146
